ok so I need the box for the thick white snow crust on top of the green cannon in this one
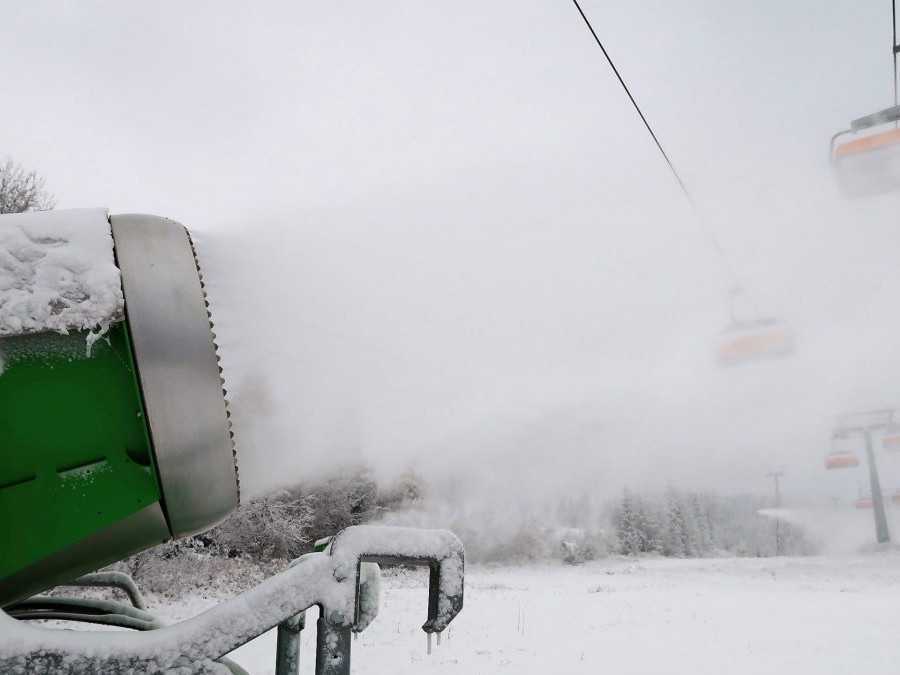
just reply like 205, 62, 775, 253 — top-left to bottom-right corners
0, 209, 125, 336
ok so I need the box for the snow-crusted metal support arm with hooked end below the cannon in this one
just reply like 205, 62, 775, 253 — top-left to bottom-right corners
0, 526, 465, 675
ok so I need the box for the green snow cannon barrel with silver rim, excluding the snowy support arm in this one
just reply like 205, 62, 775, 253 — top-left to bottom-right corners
0, 209, 238, 606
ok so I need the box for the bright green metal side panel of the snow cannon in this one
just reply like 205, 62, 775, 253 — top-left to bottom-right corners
0, 323, 160, 580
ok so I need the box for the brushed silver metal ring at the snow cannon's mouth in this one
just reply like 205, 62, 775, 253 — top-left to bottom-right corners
110, 214, 239, 538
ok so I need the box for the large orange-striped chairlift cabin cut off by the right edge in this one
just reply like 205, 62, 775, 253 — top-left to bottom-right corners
831, 105, 900, 198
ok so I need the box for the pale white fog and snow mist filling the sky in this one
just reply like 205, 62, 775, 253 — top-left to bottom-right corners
0, 0, 900, 508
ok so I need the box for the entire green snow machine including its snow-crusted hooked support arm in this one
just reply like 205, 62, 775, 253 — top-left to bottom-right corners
0, 209, 464, 675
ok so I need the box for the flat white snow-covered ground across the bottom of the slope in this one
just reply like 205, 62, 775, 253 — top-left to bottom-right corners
156, 552, 900, 675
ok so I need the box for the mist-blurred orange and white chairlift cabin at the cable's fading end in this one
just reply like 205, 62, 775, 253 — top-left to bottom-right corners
718, 288, 794, 366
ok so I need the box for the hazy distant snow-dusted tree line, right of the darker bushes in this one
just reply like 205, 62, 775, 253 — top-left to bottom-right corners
383, 488, 815, 564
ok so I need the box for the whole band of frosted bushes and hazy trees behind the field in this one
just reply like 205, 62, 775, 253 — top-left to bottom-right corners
119, 466, 814, 596
